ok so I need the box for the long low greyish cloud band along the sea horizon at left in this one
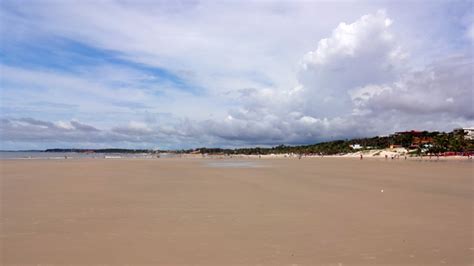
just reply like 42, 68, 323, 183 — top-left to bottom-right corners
0, 118, 218, 149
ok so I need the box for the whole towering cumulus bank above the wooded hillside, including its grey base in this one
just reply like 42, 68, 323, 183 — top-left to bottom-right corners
176, 11, 474, 143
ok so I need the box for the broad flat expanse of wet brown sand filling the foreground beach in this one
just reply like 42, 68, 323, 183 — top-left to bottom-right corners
0, 158, 474, 265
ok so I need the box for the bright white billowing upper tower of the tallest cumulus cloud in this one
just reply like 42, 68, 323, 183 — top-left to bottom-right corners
299, 10, 406, 116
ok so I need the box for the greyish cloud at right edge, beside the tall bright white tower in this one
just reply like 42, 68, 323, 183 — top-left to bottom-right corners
350, 55, 474, 120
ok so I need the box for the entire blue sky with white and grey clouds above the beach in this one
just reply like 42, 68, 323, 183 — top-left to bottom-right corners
0, 0, 474, 150
